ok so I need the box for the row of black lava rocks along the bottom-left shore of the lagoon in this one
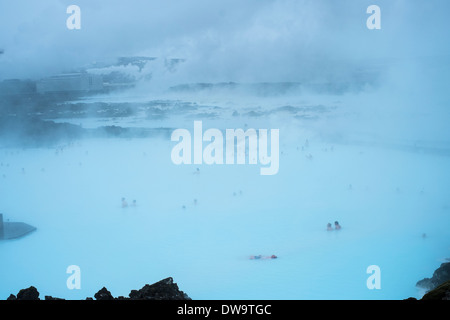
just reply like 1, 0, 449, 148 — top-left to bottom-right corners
6, 277, 192, 301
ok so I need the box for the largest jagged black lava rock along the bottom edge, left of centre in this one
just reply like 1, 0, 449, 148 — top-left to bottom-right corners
129, 277, 191, 300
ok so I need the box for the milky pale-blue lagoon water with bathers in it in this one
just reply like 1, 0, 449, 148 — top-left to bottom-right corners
0, 92, 450, 299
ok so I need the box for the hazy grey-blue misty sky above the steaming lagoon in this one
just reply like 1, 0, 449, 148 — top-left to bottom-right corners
0, 0, 450, 81
